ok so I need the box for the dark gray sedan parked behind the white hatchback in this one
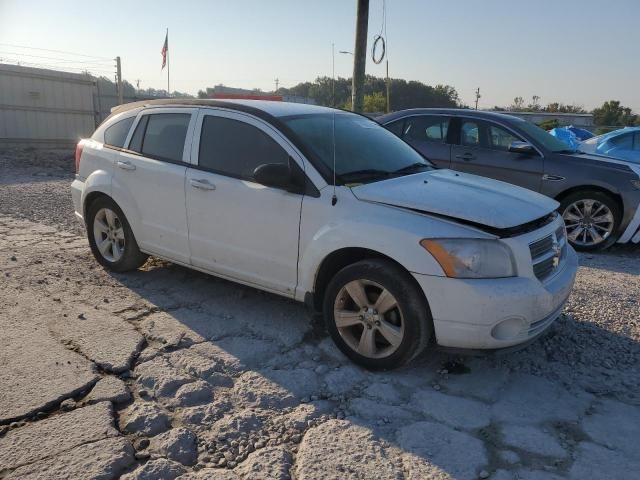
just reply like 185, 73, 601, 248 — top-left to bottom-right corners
377, 108, 640, 250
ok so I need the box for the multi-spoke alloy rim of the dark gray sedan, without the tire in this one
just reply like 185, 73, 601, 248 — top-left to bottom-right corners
562, 199, 615, 247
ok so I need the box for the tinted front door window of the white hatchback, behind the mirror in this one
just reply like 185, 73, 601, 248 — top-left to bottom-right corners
198, 115, 289, 180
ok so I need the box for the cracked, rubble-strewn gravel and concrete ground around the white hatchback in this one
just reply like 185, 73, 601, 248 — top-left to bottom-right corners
0, 150, 640, 480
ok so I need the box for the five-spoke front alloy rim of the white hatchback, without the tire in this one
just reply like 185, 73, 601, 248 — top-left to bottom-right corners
333, 279, 405, 358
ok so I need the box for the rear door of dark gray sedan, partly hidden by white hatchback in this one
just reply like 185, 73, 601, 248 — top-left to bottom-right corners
388, 115, 451, 168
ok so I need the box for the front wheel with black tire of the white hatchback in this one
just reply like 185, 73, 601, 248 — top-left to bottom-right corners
323, 259, 433, 370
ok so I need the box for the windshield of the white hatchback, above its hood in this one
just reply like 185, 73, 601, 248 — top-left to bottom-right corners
281, 111, 432, 184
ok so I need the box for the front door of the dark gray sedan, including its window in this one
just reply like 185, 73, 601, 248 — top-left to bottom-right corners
451, 118, 544, 191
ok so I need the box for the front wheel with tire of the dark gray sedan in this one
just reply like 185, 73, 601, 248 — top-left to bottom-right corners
559, 190, 622, 252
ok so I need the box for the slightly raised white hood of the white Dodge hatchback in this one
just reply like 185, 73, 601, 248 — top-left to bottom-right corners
352, 169, 559, 229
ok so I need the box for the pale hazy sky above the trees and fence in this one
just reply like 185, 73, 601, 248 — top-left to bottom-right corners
0, 0, 640, 112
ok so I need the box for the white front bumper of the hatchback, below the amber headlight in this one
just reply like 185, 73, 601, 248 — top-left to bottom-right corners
413, 248, 578, 349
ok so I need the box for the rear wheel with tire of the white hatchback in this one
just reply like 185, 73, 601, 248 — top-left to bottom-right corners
86, 196, 149, 272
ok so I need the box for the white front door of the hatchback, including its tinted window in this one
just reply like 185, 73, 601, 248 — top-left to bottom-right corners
186, 109, 303, 296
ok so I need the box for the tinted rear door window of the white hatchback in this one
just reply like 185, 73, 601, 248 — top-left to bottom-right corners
129, 113, 191, 162
